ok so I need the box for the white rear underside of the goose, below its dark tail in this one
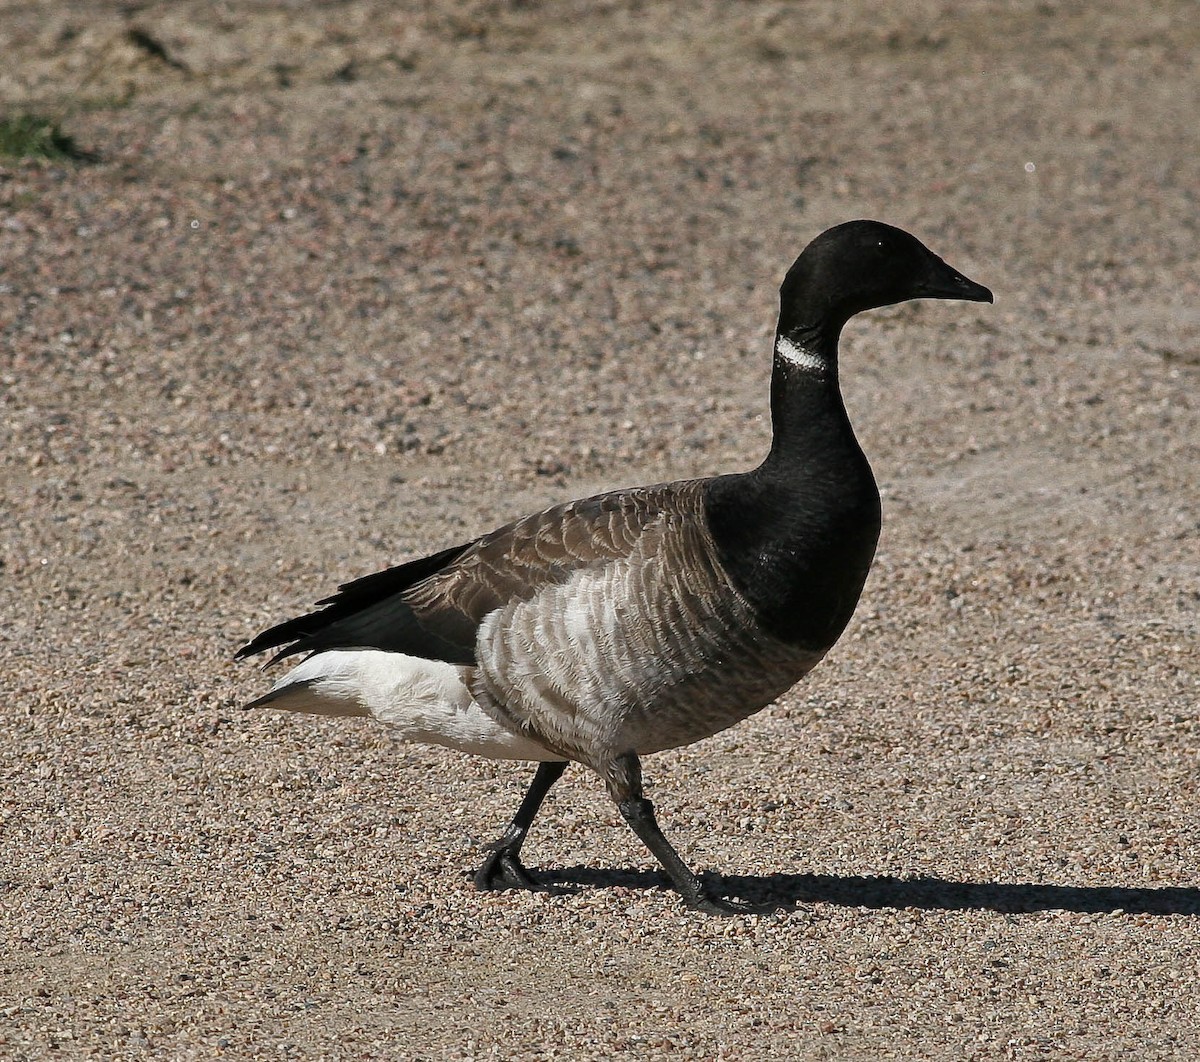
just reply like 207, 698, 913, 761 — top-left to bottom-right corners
257, 649, 562, 760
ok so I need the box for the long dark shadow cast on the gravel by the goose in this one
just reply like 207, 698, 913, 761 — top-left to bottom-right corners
538, 866, 1200, 916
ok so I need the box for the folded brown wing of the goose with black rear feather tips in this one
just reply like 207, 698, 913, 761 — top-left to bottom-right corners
238, 480, 702, 664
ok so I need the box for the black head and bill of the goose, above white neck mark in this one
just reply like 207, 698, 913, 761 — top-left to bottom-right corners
779, 221, 992, 337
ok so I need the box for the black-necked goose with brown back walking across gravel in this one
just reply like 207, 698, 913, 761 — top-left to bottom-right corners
236, 221, 992, 913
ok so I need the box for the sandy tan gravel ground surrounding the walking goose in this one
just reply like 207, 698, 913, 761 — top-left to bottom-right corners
0, 0, 1200, 1060
